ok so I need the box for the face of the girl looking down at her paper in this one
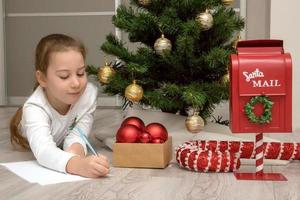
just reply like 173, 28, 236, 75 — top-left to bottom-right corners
37, 50, 87, 114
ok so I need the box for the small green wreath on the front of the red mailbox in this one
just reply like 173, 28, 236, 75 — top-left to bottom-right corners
244, 95, 274, 124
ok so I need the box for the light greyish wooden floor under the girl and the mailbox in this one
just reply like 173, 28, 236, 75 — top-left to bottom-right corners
0, 107, 300, 200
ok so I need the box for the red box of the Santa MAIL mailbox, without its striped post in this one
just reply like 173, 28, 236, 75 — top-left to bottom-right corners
230, 40, 292, 133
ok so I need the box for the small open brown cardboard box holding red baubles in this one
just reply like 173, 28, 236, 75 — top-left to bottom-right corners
112, 137, 172, 168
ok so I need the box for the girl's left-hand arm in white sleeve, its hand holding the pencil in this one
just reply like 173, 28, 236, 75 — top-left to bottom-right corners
22, 106, 109, 178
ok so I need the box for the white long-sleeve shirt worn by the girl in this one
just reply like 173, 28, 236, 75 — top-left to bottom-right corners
20, 83, 98, 172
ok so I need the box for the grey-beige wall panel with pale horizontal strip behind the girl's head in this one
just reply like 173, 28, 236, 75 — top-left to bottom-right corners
4, 0, 120, 106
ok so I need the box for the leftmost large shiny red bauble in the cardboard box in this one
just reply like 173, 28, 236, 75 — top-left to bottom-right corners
116, 124, 141, 143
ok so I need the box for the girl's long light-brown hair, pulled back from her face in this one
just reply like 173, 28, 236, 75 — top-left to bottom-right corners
10, 34, 86, 149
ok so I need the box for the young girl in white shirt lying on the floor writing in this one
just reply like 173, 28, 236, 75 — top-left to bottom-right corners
10, 34, 109, 178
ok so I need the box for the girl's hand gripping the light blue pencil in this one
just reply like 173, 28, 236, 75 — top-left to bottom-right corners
66, 155, 109, 178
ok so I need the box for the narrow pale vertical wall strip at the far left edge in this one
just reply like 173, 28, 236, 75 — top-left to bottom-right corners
0, 0, 6, 105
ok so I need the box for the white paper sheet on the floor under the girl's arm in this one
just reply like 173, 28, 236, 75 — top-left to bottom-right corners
0, 160, 89, 185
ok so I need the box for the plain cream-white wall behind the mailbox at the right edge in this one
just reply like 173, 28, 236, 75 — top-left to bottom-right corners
270, 0, 300, 130
